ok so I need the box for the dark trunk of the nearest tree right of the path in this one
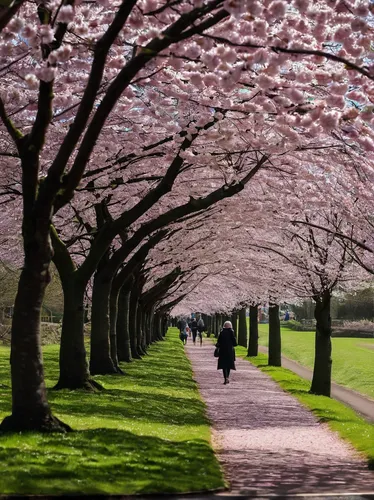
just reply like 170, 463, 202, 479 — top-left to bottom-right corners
310, 290, 332, 397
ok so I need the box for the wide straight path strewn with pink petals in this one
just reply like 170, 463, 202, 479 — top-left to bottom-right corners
186, 342, 374, 496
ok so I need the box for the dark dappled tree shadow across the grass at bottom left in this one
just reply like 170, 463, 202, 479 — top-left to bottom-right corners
0, 429, 221, 494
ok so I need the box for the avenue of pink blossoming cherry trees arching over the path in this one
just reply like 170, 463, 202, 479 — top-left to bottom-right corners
0, 0, 374, 431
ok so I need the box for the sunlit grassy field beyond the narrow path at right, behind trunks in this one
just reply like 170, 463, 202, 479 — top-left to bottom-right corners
258, 324, 374, 399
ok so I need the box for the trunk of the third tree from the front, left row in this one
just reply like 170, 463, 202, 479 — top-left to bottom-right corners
90, 272, 117, 375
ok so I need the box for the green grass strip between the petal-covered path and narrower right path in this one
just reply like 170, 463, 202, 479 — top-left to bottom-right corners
236, 347, 374, 468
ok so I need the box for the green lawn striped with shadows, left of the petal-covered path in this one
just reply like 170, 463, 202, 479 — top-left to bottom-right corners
0, 329, 224, 495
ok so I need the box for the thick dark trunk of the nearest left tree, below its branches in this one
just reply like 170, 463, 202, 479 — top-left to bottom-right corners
0, 222, 70, 432
